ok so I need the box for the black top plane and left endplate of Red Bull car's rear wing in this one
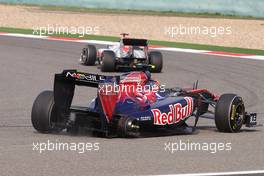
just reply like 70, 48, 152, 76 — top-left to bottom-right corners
53, 70, 120, 113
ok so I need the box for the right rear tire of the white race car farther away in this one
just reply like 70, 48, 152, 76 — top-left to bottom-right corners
149, 51, 163, 73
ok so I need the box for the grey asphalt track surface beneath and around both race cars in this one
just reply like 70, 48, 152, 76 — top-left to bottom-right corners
0, 37, 264, 176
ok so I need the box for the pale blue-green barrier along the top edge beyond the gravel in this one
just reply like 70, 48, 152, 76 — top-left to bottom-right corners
0, 0, 264, 17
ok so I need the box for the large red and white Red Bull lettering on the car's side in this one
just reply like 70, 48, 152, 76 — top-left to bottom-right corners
151, 97, 193, 125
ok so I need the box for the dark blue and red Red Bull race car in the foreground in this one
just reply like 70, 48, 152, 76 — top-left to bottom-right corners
31, 70, 257, 137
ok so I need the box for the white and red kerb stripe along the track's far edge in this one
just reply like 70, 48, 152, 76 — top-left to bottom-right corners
0, 32, 264, 60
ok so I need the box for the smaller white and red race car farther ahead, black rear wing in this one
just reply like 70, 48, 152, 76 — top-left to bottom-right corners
80, 33, 163, 73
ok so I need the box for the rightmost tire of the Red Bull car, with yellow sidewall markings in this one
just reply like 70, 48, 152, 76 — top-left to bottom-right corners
215, 94, 245, 133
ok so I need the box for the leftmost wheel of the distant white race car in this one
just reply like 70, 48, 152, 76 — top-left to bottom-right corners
81, 45, 97, 65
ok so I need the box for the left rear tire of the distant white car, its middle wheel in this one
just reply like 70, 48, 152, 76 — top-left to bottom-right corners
101, 51, 116, 72
